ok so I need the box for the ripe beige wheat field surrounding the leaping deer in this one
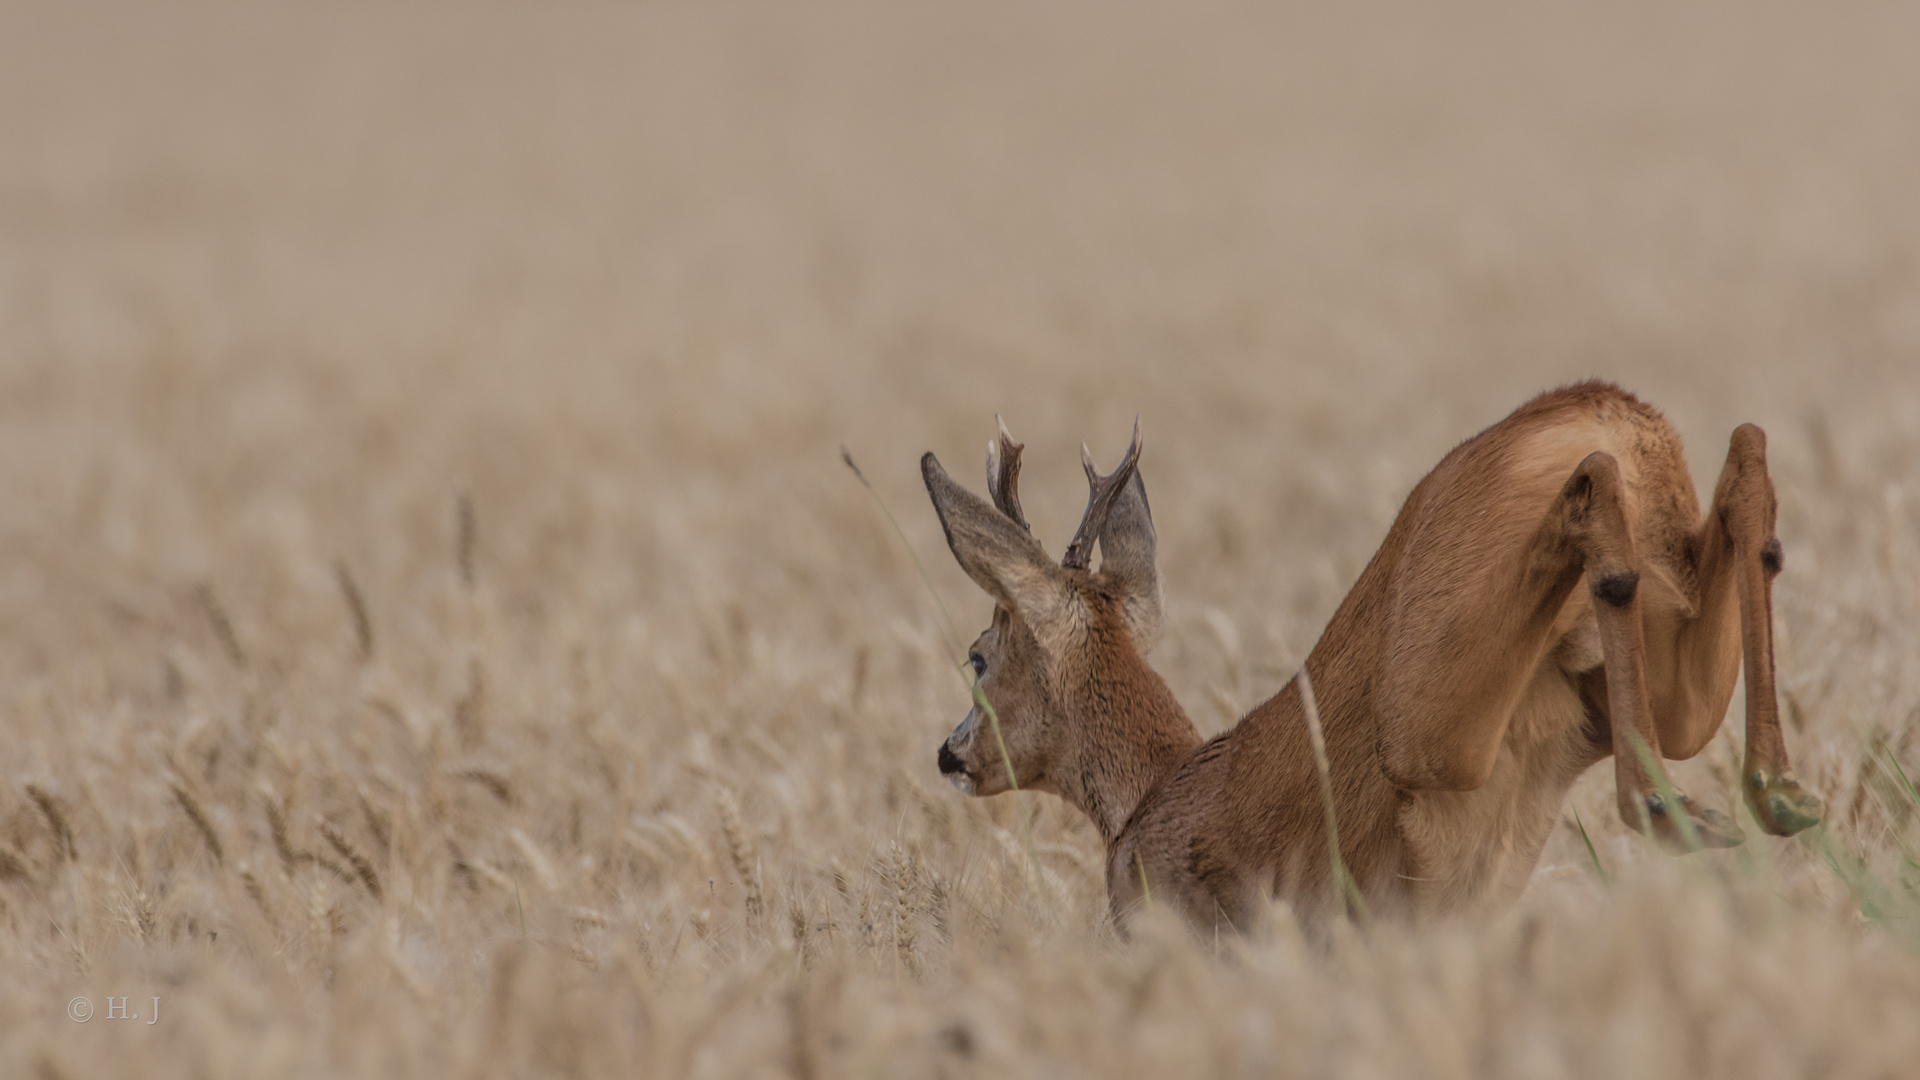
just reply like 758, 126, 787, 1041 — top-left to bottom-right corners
0, 0, 1920, 1080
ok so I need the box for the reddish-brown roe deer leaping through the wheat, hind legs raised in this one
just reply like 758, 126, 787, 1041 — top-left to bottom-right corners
920, 382, 1824, 928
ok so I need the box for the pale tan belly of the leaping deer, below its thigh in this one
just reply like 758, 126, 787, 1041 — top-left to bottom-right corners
1400, 663, 1594, 913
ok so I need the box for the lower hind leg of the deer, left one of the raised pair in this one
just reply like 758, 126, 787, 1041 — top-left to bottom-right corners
1548, 452, 1740, 847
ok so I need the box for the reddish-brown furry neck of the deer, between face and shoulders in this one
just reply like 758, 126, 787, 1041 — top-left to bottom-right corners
1052, 636, 1200, 847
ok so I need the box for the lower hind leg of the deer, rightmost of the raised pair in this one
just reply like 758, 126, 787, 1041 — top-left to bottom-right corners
1663, 425, 1826, 836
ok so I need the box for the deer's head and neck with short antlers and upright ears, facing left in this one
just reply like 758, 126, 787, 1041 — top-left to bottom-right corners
920, 421, 1200, 838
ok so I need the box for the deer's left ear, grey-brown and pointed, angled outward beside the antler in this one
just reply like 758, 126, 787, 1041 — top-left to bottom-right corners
920, 454, 1071, 642
